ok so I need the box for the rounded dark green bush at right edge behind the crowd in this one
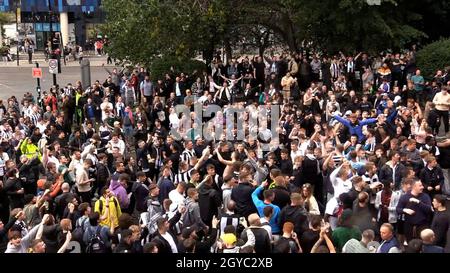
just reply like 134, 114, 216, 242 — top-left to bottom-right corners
416, 39, 450, 79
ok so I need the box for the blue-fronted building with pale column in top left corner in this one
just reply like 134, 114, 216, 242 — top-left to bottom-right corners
0, 0, 104, 49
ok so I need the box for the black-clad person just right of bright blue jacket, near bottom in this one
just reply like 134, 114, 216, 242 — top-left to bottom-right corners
280, 192, 309, 238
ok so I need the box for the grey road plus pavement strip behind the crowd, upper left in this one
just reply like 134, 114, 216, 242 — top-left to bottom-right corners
0, 54, 118, 100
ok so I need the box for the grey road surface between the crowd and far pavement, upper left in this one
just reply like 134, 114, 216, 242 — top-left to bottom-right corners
0, 57, 114, 100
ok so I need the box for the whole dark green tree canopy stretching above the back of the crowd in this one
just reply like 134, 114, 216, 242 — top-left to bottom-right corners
102, 0, 450, 64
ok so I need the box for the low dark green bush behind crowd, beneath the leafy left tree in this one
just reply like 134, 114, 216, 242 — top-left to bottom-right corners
150, 56, 206, 80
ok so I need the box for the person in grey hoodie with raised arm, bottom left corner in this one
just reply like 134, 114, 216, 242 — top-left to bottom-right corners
5, 214, 50, 253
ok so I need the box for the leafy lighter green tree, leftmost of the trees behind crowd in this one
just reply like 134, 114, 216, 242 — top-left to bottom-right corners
102, 0, 226, 66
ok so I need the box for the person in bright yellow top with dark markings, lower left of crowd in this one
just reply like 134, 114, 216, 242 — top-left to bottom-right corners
94, 187, 122, 228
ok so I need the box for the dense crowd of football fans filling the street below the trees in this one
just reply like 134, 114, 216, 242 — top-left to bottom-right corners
0, 48, 450, 253
